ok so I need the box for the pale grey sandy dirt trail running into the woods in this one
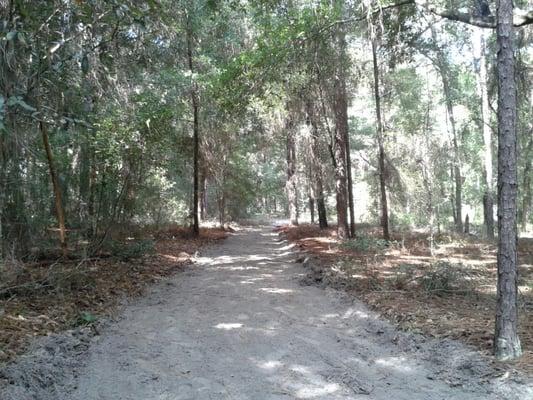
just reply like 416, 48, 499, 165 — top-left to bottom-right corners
1, 228, 533, 400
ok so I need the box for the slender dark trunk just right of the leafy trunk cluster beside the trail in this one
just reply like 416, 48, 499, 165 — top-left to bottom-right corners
372, 38, 390, 240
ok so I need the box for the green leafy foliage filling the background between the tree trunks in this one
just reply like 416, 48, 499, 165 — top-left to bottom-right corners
0, 0, 532, 258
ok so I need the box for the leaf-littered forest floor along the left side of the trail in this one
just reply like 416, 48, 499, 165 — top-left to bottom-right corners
0, 227, 226, 364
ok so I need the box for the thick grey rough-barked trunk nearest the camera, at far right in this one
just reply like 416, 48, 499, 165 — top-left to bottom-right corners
494, 0, 522, 360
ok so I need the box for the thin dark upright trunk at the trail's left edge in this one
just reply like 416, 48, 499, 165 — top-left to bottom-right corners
187, 19, 200, 236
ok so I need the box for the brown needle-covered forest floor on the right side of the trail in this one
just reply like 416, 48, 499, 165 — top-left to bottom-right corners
280, 225, 533, 374
